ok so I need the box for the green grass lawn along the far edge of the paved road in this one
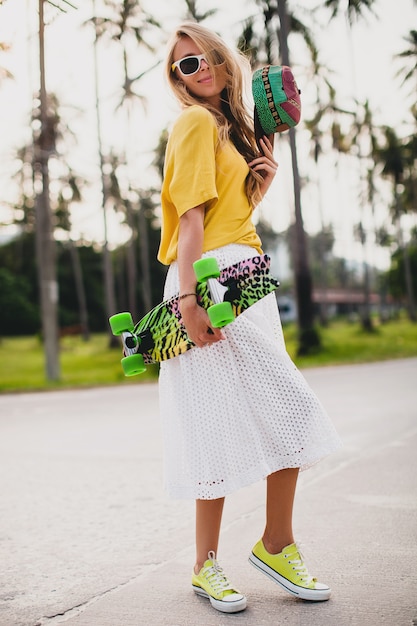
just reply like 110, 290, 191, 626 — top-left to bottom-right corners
0, 319, 417, 393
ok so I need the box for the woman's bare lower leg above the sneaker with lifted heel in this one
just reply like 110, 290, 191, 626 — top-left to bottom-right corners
262, 468, 299, 554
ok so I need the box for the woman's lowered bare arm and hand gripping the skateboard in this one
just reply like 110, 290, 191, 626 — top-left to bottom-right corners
178, 204, 224, 348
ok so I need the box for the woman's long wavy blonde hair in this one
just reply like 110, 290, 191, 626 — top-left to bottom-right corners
165, 22, 262, 207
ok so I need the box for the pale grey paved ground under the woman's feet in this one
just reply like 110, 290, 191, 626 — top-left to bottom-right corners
0, 359, 417, 626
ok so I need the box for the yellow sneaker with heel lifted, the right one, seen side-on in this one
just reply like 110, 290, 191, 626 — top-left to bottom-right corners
249, 540, 331, 602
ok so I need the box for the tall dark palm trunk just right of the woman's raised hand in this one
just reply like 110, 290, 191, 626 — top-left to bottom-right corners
278, 0, 320, 355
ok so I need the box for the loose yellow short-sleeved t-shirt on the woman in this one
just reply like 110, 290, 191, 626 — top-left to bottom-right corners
158, 105, 262, 265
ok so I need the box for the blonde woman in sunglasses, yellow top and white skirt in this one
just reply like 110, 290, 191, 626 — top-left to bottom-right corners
158, 23, 339, 613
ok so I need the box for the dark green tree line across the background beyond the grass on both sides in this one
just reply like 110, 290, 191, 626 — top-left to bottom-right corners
0, 217, 417, 340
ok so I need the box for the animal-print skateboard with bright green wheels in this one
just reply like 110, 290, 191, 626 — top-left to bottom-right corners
109, 254, 279, 376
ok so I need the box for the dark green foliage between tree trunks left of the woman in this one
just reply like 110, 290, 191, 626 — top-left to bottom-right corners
0, 227, 165, 336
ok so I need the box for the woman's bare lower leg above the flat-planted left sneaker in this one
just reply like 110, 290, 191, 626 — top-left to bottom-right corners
194, 498, 224, 574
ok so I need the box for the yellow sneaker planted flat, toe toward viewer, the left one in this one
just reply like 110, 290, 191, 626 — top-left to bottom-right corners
191, 552, 246, 613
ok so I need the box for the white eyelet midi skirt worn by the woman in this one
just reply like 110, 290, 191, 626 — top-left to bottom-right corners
159, 244, 341, 500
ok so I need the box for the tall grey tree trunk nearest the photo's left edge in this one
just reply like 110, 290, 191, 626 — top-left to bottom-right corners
34, 0, 61, 381
